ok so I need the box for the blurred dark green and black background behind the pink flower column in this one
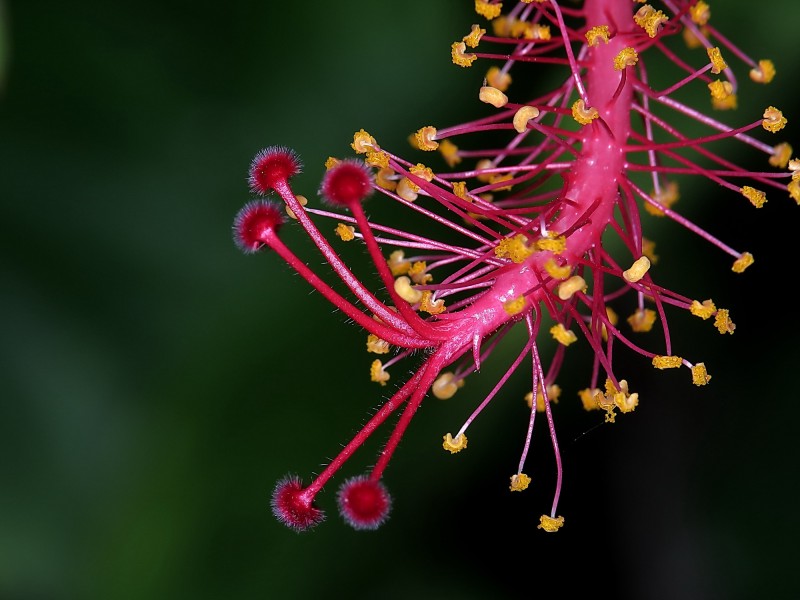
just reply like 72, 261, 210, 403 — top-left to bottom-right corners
0, 0, 800, 600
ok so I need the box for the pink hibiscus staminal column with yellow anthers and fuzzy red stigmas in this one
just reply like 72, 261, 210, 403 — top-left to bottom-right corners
234, 0, 800, 531
